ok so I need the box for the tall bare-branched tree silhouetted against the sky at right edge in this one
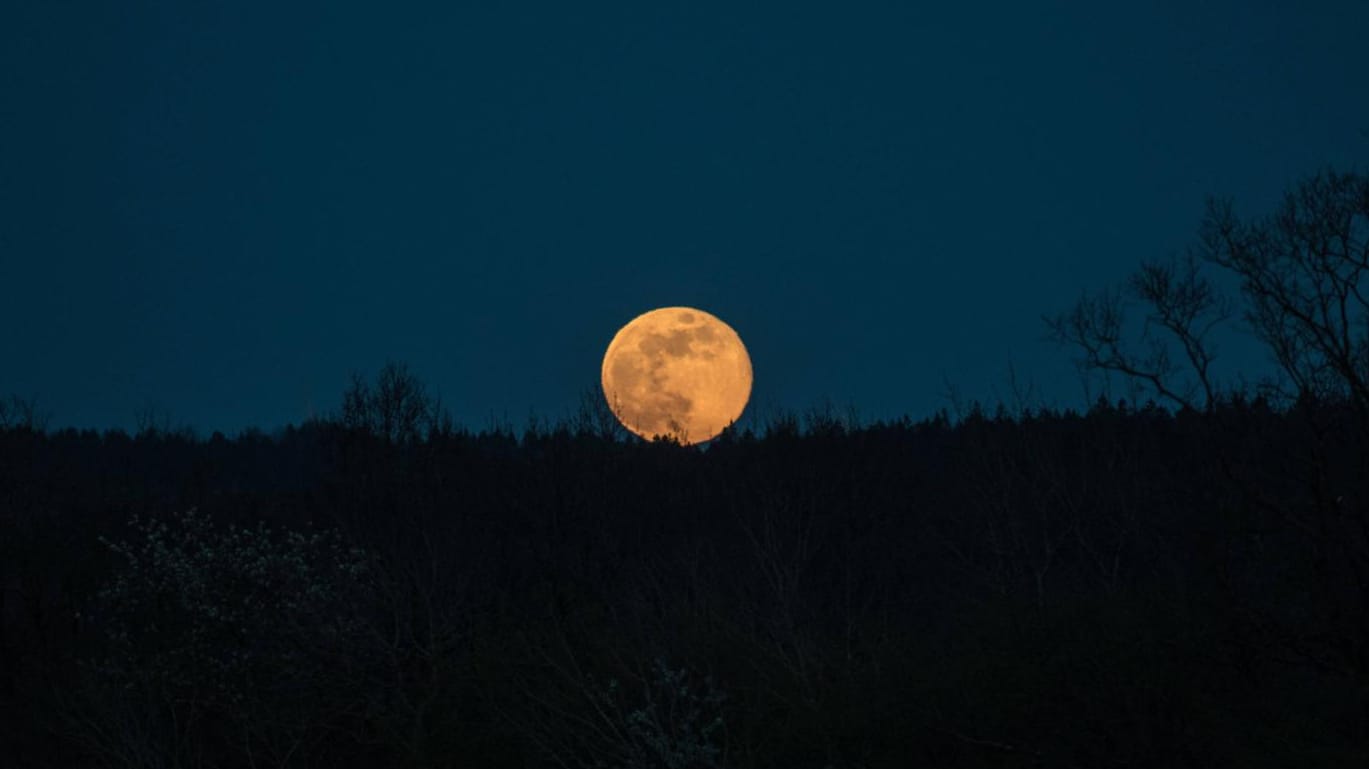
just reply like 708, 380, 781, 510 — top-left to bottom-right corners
1045, 171, 1369, 424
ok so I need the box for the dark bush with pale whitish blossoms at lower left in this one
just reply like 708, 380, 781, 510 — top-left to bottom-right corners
71, 509, 371, 765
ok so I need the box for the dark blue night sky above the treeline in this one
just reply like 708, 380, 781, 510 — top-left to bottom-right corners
0, 0, 1369, 431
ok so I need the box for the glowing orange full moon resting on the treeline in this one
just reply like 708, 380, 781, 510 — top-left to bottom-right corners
602, 307, 752, 446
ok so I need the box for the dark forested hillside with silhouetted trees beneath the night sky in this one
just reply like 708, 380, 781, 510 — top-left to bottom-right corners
0, 166, 1369, 769
